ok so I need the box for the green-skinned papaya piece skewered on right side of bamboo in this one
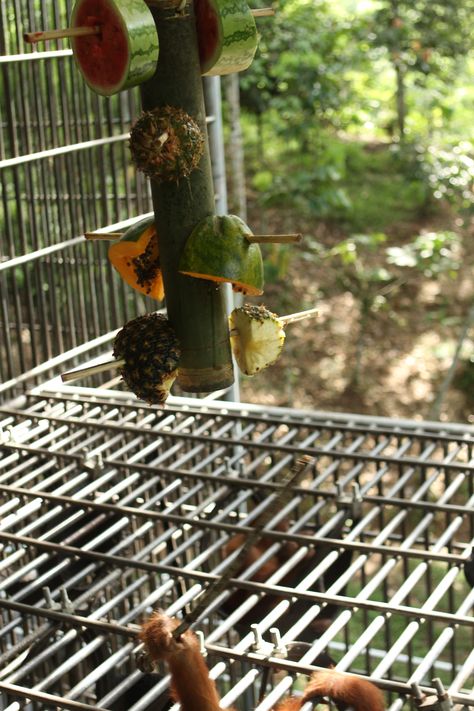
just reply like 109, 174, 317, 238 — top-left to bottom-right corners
179, 215, 263, 296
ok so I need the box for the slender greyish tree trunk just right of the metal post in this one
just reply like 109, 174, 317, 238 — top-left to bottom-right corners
225, 74, 247, 222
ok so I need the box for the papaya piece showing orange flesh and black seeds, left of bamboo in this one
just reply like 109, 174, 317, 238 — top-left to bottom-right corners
109, 216, 165, 301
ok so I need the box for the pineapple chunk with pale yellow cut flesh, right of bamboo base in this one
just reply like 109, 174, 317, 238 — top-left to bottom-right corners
229, 304, 285, 375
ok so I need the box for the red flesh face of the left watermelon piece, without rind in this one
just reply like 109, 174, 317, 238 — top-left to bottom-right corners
74, 0, 129, 90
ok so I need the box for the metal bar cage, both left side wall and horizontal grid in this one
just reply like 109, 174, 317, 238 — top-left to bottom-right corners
0, 0, 474, 711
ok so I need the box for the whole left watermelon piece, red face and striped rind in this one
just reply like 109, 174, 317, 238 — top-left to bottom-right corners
70, 0, 159, 96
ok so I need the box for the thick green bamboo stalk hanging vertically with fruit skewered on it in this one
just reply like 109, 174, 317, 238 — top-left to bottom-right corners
141, 3, 234, 392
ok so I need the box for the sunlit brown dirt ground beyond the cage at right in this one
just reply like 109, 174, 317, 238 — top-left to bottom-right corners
241, 205, 474, 424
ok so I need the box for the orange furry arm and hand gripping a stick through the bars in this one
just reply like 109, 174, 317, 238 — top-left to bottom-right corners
140, 612, 232, 711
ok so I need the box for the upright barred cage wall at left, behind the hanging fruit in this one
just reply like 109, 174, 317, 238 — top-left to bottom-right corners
0, 0, 150, 394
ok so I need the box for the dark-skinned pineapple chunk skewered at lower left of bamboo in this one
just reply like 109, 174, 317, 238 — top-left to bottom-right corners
113, 313, 181, 405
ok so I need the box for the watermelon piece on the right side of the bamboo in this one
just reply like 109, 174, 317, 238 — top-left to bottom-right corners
194, 0, 258, 76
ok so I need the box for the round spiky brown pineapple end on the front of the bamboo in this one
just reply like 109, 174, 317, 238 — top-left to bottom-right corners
130, 106, 204, 182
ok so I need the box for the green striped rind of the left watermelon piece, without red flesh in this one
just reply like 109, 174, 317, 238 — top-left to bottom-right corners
70, 0, 159, 96
